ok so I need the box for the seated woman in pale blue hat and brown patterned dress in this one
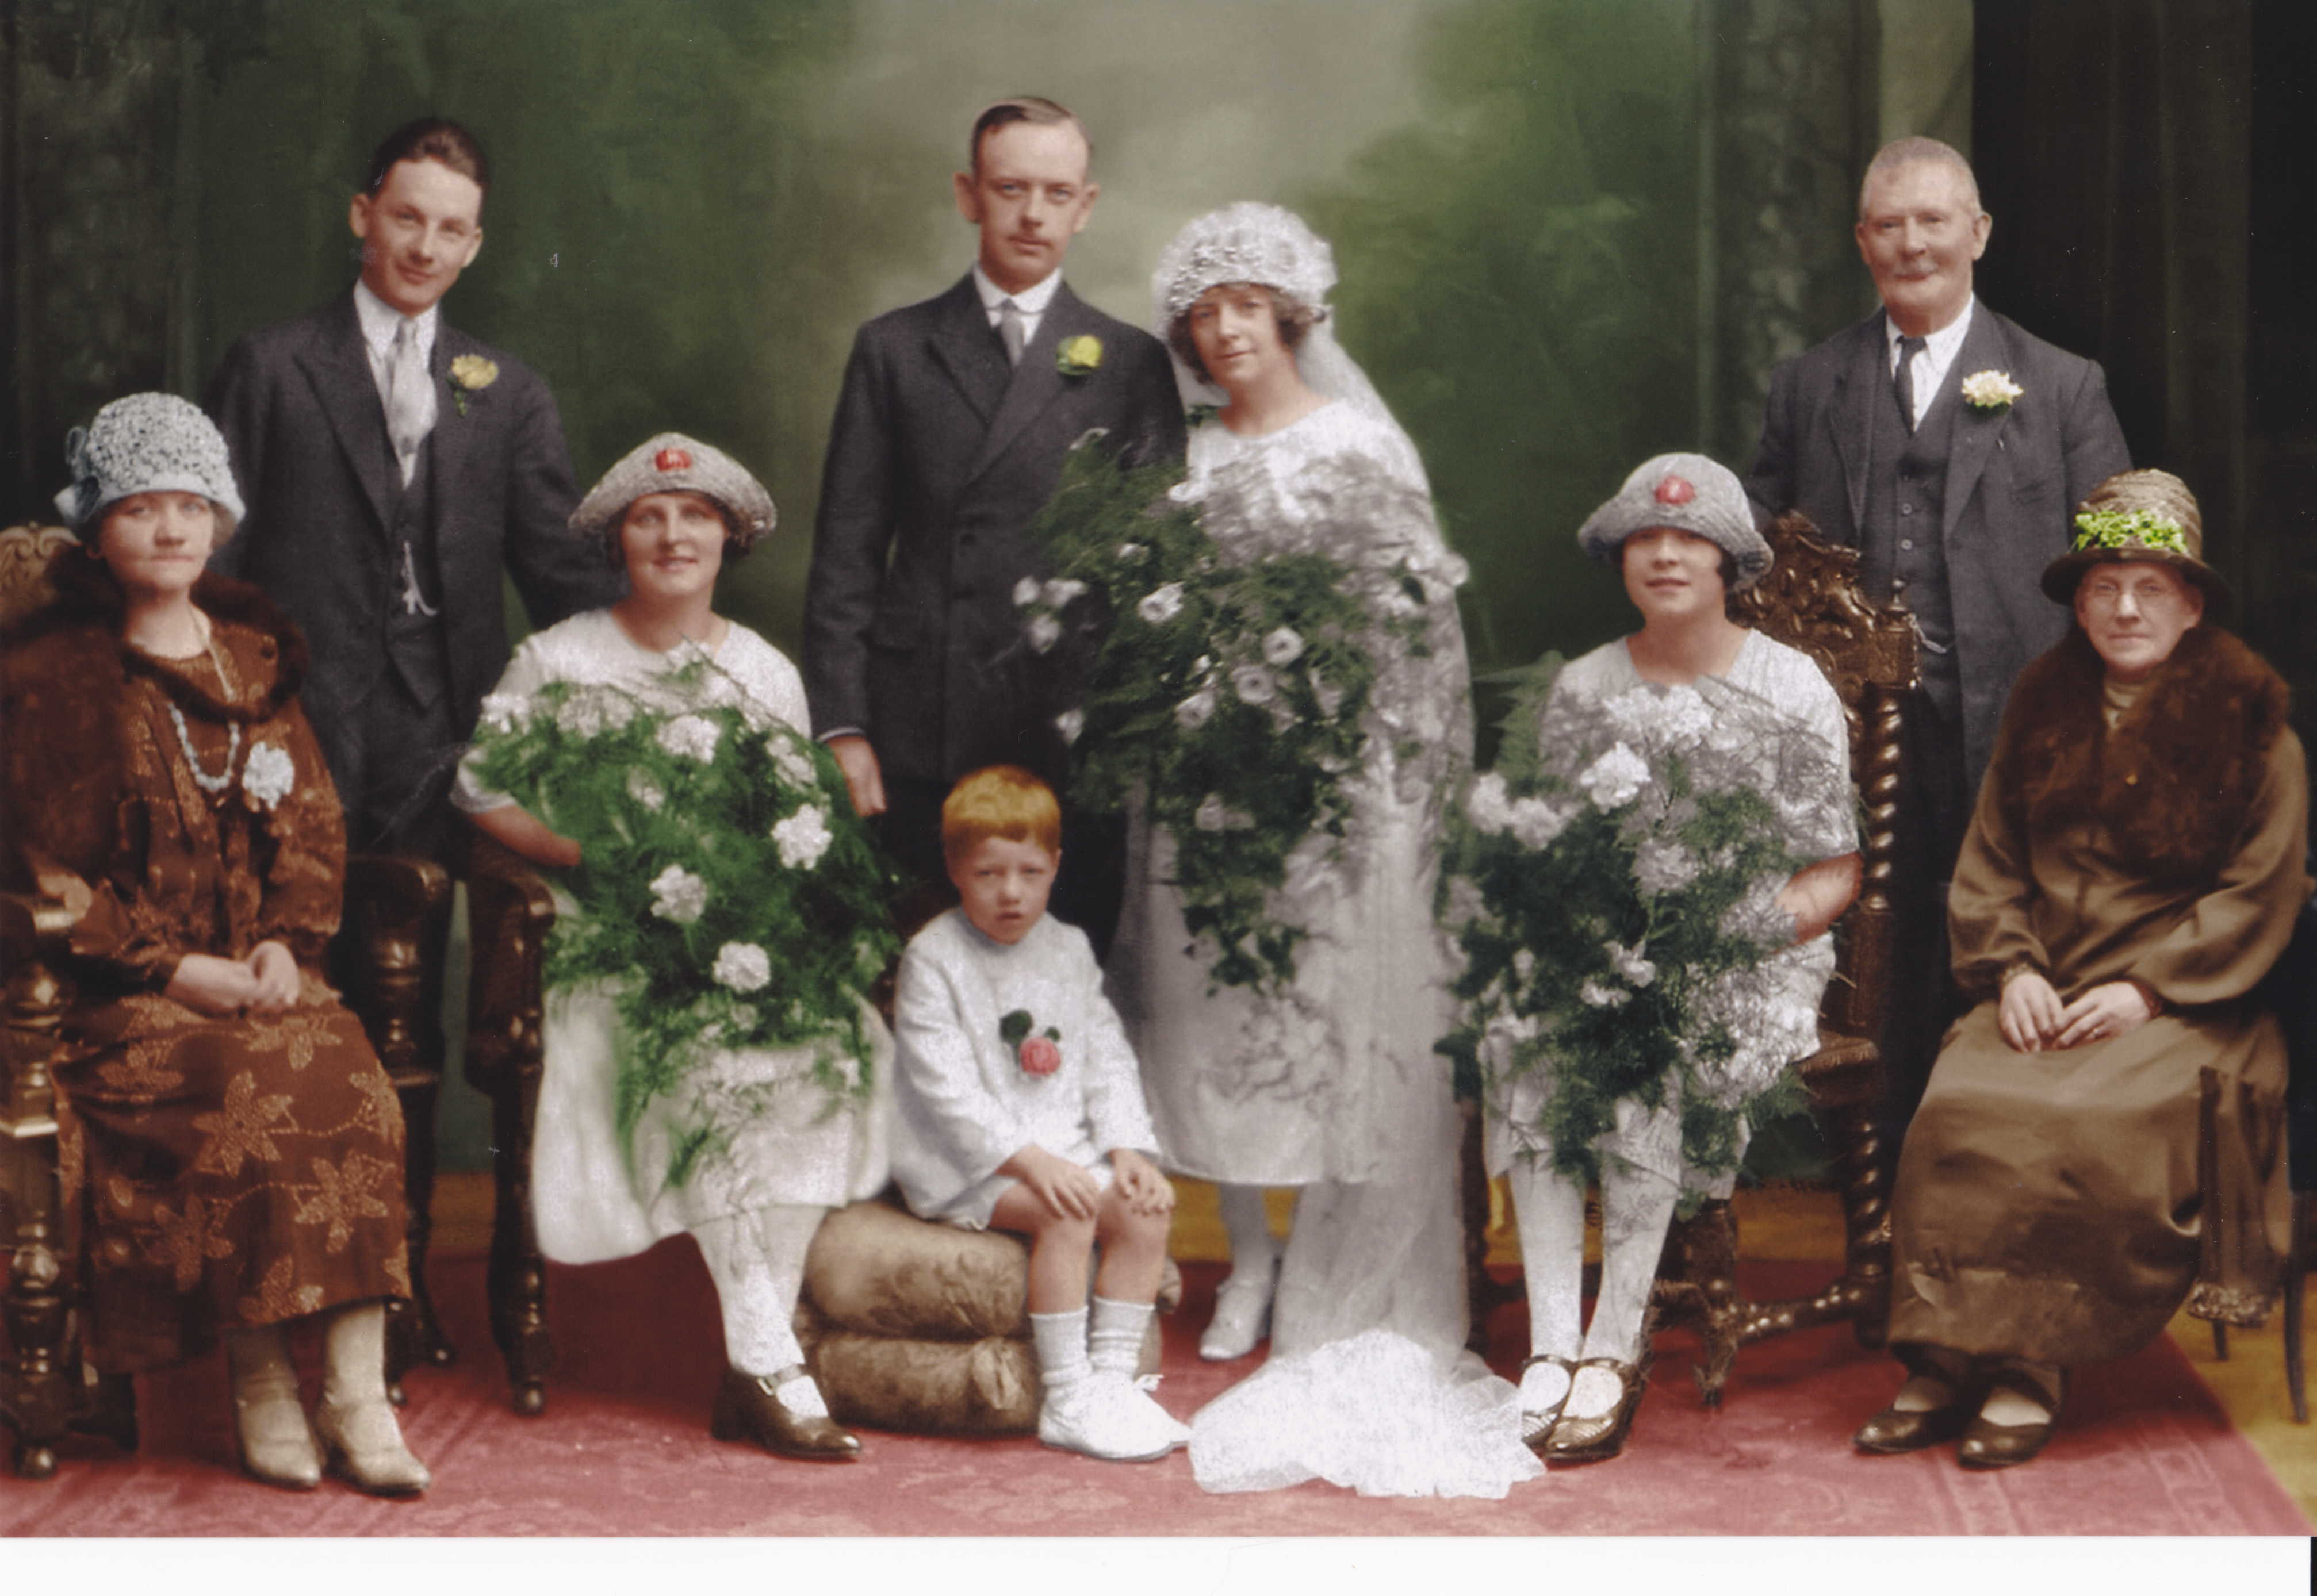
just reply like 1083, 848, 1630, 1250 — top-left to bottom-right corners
0, 394, 428, 1494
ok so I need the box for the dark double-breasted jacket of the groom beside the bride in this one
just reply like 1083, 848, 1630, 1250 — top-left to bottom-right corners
804, 275, 1184, 783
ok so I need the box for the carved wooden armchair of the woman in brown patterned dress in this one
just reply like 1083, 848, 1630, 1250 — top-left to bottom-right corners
0, 526, 450, 1480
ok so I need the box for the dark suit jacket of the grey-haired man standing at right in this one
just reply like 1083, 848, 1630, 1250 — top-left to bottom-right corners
1745, 304, 2132, 792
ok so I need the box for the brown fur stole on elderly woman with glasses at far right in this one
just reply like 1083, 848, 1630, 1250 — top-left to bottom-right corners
1997, 626, 2292, 878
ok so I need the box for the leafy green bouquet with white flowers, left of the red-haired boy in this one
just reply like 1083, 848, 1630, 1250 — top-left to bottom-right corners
475, 655, 899, 1184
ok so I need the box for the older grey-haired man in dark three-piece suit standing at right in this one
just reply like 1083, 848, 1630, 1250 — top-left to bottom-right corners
1747, 139, 2132, 1112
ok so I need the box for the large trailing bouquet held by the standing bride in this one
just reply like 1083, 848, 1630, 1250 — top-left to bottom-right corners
1013, 435, 1453, 989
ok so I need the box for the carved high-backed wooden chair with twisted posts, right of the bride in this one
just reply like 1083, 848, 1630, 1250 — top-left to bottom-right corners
1464, 514, 1916, 1406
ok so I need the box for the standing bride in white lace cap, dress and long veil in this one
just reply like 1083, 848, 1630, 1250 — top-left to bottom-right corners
1110, 204, 1538, 1497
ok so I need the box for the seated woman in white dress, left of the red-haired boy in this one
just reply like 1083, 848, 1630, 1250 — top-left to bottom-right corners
452, 433, 892, 1459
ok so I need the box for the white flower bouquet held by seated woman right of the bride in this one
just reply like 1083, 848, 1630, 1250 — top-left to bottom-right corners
1441, 655, 1847, 1179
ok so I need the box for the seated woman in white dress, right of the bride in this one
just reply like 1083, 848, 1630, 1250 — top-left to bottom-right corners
1471, 454, 1858, 1464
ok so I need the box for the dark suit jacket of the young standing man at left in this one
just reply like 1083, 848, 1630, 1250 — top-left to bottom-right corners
204, 292, 621, 792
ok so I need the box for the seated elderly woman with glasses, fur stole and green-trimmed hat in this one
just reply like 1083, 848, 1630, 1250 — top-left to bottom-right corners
1856, 470, 2310, 1468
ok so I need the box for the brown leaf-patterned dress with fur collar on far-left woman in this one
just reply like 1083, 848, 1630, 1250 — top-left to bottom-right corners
0, 572, 410, 1369
